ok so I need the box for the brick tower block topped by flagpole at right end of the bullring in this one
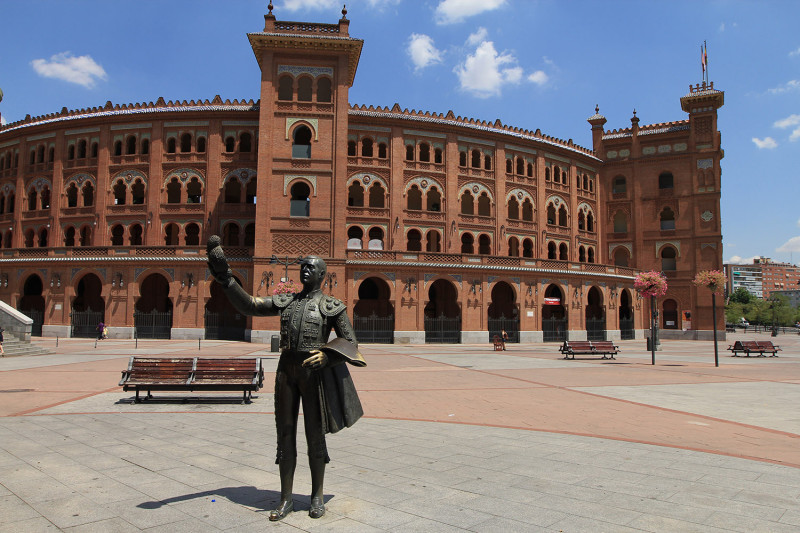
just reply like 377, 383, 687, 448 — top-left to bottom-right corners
588, 82, 724, 338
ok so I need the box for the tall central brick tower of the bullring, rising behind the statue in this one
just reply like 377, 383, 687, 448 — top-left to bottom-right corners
248, 2, 363, 341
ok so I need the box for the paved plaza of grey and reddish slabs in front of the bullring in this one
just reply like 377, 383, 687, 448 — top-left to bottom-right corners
0, 333, 800, 533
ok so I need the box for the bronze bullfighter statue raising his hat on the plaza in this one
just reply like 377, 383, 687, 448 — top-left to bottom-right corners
208, 235, 367, 521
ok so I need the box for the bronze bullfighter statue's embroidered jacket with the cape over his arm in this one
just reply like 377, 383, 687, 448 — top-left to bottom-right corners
225, 281, 367, 433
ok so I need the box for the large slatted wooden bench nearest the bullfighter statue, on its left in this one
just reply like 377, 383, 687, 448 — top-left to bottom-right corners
119, 357, 264, 403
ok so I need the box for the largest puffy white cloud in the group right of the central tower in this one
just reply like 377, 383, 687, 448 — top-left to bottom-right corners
454, 41, 522, 98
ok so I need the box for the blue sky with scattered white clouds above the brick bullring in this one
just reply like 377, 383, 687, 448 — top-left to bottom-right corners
0, 0, 800, 263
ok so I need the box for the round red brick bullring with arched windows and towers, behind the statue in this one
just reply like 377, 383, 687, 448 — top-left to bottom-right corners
0, 12, 723, 342
